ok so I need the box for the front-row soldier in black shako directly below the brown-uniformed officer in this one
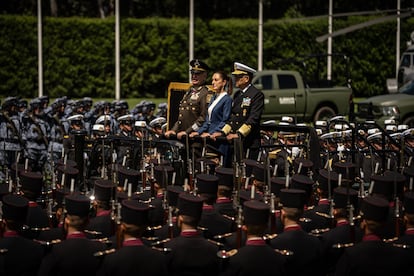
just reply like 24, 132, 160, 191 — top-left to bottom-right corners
165, 193, 219, 275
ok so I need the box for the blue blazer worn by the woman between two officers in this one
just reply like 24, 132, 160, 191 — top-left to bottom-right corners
198, 94, 233, 134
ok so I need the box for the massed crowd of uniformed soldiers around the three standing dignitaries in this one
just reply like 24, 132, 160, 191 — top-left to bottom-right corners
0, 59, 414, 275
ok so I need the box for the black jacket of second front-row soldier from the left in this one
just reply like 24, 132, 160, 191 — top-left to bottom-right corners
38, 233, 106, 276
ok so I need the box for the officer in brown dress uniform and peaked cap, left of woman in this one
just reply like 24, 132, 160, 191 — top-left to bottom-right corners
165, 59, 209, 139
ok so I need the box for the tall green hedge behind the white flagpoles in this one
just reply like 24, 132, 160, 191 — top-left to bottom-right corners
0, 15, 414, 98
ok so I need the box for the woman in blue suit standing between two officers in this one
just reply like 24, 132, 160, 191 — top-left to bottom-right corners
190, 71, 233, 166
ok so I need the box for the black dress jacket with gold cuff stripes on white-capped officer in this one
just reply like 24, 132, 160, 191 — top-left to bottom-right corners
223, 85, 264, 153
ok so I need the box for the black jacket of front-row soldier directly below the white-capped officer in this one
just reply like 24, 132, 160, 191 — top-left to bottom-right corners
222, 239, 285, 276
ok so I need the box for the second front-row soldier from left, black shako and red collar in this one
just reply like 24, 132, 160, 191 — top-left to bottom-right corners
38, 193, 106, 275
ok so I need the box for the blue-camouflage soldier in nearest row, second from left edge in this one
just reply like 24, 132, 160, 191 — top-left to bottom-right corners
23, 98, 50, 171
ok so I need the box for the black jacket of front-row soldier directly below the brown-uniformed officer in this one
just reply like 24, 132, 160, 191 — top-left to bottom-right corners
165, 232, 219, 276
